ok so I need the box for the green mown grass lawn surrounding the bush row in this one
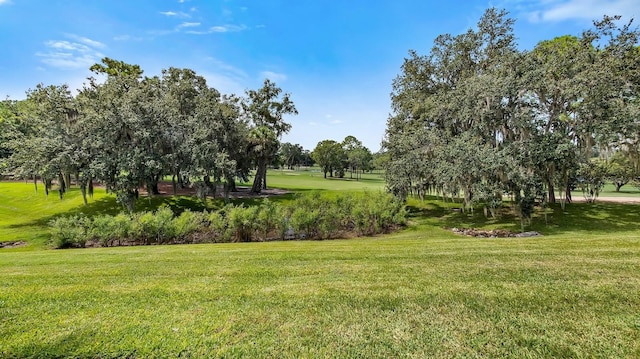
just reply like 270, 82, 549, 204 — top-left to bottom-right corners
0, 172, 640, 358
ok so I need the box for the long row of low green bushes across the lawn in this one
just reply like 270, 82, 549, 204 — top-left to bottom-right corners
50, 192, 406, 248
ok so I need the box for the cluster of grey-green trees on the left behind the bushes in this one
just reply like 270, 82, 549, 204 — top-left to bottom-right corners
0, 58, 297, 211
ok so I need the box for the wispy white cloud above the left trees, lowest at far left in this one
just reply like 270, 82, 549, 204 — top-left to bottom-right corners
36, 34, 106, 69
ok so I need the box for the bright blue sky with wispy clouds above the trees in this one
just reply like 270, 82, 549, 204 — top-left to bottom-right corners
0, 0, 640, 151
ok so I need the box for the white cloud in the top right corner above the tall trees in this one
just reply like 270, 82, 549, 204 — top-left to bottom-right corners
511, 0, 640, 22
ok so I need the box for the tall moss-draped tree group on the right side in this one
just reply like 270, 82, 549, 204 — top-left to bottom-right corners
383, 9, 640, 217
